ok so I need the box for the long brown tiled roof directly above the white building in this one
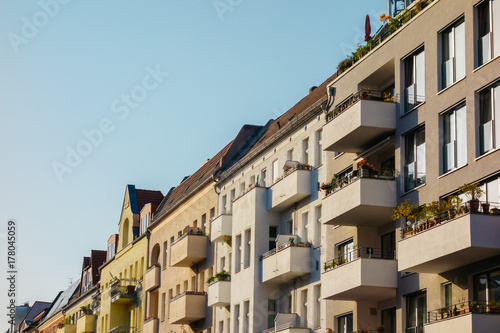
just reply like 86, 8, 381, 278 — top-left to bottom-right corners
222, 73, 337, 178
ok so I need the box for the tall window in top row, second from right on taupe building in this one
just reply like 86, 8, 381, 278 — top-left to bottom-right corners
441, 18, 465, 89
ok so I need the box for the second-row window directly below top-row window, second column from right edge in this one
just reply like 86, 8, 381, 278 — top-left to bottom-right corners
442, 105, 467, 173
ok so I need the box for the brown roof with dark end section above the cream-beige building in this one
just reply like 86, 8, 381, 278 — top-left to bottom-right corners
153, 125, 267, 221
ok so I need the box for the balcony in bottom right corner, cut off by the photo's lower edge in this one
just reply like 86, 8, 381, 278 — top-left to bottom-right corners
425, 301, 500, 333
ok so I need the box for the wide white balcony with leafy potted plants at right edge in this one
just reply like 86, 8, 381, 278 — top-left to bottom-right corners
398, 207, 500, 274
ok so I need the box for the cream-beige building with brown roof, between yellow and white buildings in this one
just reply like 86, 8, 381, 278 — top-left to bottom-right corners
143, 125, 267, 333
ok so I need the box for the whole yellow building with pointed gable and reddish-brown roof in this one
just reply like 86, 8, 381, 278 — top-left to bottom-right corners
93, 185, 163, 333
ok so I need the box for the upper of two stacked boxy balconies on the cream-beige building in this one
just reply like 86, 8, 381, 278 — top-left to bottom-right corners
170, 231, 208, 267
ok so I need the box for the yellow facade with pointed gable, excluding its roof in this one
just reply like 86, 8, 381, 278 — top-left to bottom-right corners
97, 187, 148, 333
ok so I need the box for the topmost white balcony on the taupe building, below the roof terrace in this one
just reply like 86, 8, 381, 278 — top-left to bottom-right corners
323, 90, 396, 153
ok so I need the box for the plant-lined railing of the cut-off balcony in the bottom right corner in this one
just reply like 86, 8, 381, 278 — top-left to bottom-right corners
427, 300, 500, 324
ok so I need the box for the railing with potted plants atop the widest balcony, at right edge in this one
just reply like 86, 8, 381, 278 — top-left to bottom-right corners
401, 201, 500, 239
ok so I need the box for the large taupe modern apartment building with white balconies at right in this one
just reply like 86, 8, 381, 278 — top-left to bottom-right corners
322, 0, 500, 332
